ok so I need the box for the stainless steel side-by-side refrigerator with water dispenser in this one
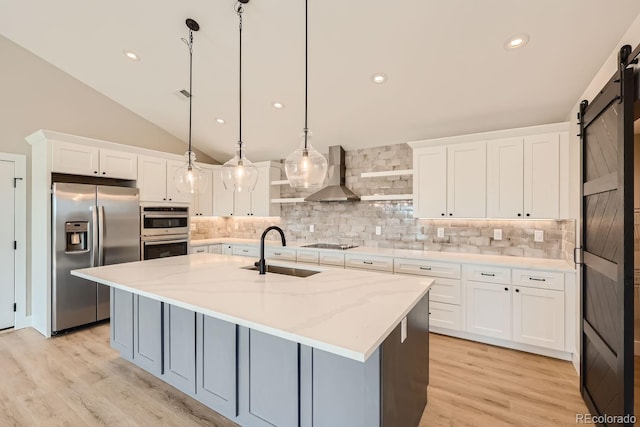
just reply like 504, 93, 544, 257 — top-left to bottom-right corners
51, 182, 140, 334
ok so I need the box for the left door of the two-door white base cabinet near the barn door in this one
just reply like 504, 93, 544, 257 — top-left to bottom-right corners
465, 281, 511, 340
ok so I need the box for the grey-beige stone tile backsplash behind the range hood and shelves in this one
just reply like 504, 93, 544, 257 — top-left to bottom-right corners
191, 144, 575, 259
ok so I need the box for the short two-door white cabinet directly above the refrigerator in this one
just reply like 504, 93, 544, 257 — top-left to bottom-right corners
51, 141, 137, 180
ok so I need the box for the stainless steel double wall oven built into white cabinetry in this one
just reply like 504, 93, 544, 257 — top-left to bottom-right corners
140, 206, 189, 260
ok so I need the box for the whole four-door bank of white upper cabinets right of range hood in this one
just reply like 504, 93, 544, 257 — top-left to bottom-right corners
409, 123, 569, 219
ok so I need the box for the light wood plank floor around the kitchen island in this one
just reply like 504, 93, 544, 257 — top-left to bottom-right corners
0, 324, 604, 427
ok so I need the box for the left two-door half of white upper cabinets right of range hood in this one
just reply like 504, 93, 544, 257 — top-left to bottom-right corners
413, 142, 487, 218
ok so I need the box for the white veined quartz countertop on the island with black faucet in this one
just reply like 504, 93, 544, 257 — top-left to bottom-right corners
71, 256, 433, 362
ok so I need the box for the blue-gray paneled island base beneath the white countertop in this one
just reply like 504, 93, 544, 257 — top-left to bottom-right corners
80, 261, 429, 427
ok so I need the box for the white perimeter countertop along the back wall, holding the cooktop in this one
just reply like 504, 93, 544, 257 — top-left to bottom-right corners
191, 237, 575, 272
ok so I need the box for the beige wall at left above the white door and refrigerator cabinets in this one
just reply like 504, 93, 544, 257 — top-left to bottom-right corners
0, 36, 218, 315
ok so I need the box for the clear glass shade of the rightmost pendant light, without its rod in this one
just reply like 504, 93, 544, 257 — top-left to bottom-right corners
284, 135, 327, 189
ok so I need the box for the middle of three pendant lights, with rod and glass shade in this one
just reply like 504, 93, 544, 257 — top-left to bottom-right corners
221, 0, 258, 192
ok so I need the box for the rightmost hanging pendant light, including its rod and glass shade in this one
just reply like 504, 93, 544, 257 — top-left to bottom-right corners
284, 0, 327, 189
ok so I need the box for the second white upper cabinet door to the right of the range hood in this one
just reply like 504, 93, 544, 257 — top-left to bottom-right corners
448, 142, 487, 218
